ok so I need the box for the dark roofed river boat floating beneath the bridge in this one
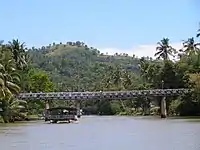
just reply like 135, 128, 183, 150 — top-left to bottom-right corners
45, 107, 80, 123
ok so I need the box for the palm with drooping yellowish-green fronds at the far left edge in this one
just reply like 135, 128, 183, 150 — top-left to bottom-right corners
0, 51, 20, 122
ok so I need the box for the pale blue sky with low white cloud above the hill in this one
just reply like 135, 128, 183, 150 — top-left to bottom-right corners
0, 0, 200, 57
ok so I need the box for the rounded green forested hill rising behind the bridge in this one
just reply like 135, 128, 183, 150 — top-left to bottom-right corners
28, 41, 150, 91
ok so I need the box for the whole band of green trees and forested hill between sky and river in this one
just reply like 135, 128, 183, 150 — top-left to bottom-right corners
0, 25, 200, 122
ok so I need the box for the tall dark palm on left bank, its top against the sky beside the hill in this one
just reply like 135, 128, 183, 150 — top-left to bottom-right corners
8, 39, 27, 69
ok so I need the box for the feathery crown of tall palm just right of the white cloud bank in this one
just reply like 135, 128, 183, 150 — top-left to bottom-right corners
155, 38, 176, 60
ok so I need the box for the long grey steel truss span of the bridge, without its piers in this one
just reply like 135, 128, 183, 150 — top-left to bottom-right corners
17, 89, 191, 100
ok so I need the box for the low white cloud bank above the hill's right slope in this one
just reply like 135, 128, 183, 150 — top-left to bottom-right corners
100, 43, 182, 58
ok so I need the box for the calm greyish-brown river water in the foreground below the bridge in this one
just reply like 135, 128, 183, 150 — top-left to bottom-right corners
0, 116, 200, 150
